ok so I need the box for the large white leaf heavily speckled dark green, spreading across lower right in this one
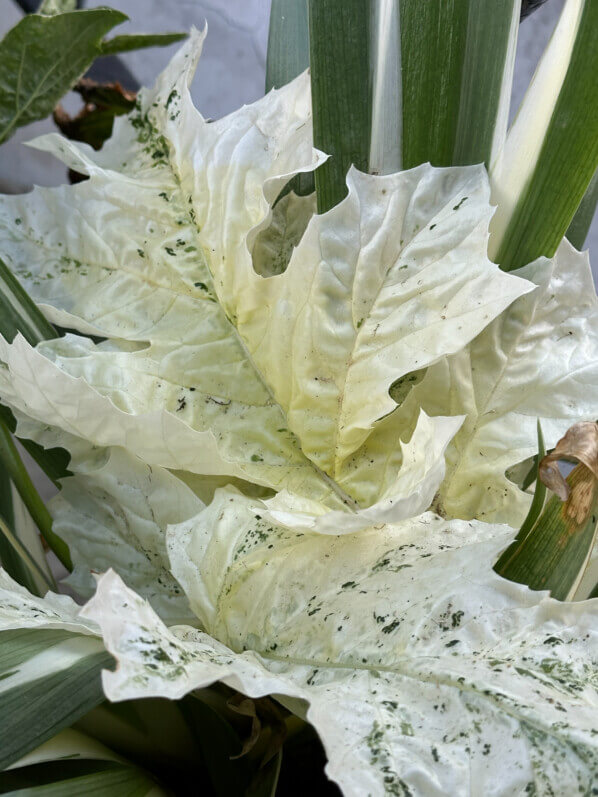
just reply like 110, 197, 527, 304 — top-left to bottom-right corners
83, 489, 598, 797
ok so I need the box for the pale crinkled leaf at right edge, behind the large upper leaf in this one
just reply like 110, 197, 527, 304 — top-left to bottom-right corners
397, 241, 598, 526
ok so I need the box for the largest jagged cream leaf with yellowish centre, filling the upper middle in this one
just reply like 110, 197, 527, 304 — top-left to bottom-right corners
0, 28, 532, 508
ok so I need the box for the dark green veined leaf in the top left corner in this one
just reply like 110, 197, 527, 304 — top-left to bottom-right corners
0, 8, 127, 142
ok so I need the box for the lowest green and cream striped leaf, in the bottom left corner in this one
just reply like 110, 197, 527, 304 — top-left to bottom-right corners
0, 729, 166, 797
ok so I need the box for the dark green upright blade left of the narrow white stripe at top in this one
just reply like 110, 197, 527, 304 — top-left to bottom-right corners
309, 0, 372, 213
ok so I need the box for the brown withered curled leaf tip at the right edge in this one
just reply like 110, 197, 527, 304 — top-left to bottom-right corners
539, 421, 598, 500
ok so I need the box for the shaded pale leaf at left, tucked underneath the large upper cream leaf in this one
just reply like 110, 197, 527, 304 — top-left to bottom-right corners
49, 448, 203, 623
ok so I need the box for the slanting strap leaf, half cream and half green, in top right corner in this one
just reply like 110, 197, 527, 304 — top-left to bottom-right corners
489, 0, 598, 270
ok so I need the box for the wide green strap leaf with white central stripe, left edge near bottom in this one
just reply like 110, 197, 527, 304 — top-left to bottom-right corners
0, 628, 112, 769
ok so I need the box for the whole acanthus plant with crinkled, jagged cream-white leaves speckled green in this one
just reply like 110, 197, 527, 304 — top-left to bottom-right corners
0, 1, 598, 797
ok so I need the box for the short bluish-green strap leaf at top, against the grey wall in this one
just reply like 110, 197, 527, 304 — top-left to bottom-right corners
266, 0, 309, 91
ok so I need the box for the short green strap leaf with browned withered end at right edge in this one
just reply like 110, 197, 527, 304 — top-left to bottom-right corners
495, 465, 598, 601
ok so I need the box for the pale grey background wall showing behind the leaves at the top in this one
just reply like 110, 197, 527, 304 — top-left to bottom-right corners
0, 0, 598, 268
